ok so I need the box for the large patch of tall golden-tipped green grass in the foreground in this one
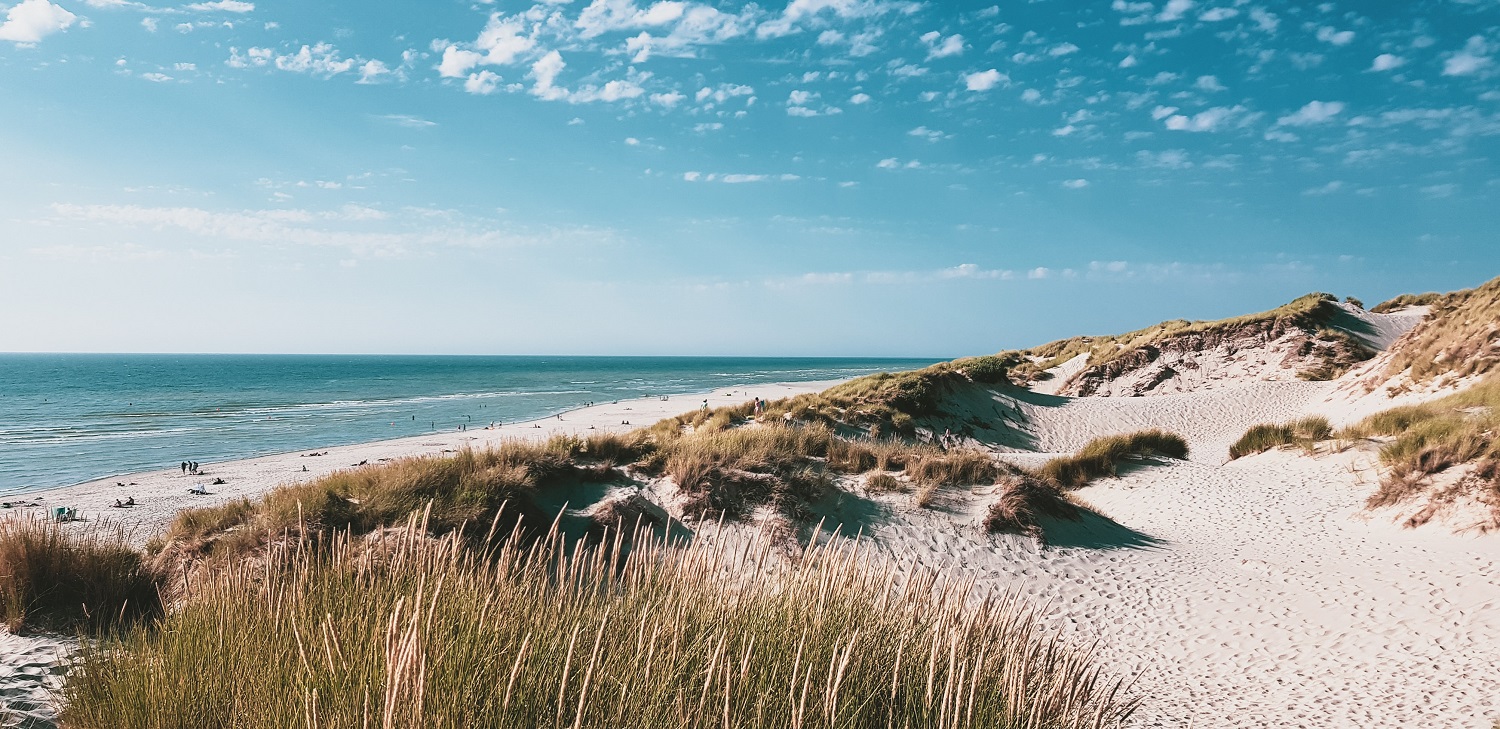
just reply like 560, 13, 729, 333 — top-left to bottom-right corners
62, 521, 1134, 729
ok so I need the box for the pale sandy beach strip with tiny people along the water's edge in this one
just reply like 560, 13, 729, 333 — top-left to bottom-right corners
0, 380, 845, 543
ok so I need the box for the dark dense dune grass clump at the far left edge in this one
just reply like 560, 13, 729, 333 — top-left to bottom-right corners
0, 516, 161, 632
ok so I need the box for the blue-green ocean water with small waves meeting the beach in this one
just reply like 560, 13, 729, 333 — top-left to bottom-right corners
0, 354, 935, 494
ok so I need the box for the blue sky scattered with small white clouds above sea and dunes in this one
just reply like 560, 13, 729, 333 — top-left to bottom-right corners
0, 0, 1500, 357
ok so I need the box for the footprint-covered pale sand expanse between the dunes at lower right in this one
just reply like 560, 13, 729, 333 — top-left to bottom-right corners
866, 452, 1500, 729
